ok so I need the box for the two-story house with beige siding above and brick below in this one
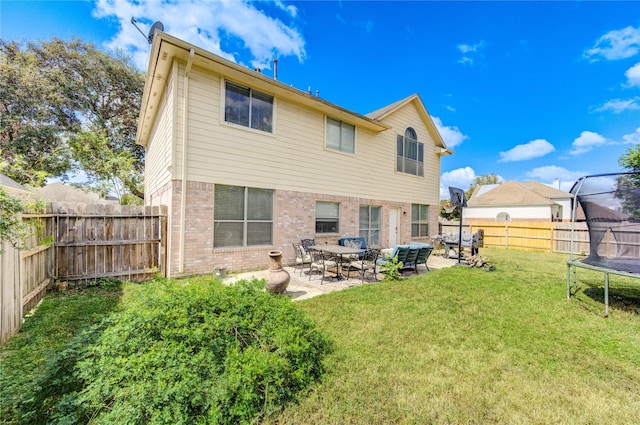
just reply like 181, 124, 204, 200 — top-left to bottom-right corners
137, 32, 451, 277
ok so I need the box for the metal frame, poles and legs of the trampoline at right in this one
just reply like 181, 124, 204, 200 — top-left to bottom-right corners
567, 173, 640, 317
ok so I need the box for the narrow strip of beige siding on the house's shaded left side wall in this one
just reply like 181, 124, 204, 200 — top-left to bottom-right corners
145, 67, 175, 193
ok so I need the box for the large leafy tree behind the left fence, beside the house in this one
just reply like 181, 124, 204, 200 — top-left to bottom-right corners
0, 38, 144, 200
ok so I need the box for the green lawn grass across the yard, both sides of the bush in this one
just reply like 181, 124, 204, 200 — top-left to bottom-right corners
0, 249, 640, 424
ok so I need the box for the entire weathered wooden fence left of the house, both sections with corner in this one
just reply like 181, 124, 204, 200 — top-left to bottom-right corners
0, 203, 167, 345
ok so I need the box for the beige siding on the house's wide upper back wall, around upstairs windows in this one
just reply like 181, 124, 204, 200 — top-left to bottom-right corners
165, 64, 439, 203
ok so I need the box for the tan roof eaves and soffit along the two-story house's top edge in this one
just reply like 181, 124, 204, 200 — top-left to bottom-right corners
136, 31, 400, 148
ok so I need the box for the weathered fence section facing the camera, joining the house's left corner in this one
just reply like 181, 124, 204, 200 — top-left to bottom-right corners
52, 204, 167, 281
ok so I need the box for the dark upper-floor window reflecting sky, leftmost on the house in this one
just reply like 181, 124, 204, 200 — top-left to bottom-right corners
224, 81, 273, 133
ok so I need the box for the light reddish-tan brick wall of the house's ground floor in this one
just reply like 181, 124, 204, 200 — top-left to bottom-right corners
147, 180, 439, 277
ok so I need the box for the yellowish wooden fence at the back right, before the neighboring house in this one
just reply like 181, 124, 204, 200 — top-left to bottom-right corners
440, 221, 589, 255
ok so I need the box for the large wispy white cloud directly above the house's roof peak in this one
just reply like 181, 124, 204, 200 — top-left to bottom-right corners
94, 0, 306, 69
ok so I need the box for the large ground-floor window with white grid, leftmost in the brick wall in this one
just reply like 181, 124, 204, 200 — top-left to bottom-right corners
213, 185, 273, 248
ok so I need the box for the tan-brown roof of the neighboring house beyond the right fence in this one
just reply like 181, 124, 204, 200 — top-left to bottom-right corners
467, 180, 572, 207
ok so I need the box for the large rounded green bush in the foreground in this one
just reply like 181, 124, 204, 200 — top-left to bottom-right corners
60, 281, 330, 424
